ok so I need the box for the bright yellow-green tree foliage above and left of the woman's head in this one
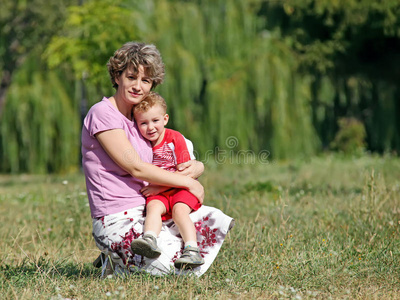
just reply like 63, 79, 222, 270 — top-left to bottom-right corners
45, 0, 143, 97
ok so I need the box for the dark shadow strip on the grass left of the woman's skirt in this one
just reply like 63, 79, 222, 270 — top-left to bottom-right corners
0, 258, 99, 280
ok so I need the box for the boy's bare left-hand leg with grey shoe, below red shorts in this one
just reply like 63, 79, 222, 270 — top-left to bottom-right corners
131, 200, 166, 258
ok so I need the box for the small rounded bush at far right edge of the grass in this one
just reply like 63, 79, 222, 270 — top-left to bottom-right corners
331, 118, 366, 155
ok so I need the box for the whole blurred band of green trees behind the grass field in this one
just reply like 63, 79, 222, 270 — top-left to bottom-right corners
0, 0, 400, 172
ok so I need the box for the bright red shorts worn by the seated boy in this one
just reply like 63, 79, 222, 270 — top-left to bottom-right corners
146, 189, 201, 221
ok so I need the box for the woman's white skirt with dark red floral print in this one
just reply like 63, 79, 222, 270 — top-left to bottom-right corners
93, 205, 234, 276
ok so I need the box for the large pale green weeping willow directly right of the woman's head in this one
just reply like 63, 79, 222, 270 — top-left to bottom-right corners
134, 0, 318, 158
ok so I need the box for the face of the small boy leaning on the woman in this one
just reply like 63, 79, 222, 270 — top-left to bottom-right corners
135, 105, 169, 147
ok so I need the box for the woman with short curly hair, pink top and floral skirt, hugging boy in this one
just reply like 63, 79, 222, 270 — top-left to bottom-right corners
82, 42, 233, 276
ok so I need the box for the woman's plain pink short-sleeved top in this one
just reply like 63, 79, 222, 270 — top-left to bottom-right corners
82, 98, 153, 218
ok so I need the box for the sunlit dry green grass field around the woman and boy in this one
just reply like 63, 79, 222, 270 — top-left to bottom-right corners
0, 155, 400, 299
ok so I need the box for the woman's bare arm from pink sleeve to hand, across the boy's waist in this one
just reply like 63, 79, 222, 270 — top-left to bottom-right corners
96, 129, 204, 203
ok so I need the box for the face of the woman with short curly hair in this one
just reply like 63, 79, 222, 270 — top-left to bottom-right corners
115, 65, 153, 105
